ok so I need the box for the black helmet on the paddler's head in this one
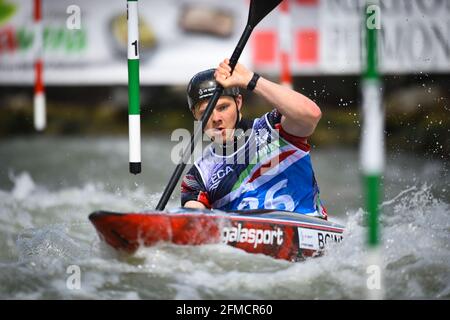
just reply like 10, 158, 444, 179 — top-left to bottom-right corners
187, 69, 239, 111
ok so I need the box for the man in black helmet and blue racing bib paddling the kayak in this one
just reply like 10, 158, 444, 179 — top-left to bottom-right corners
181, 59, 327, 219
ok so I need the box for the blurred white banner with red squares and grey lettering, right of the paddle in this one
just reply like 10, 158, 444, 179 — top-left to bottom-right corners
252, 0, 450, 75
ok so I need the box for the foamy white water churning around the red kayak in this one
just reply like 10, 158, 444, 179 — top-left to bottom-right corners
0, 168, 450, 299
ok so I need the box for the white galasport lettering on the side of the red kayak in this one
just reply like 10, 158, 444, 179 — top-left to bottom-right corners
222, 223, 283, 248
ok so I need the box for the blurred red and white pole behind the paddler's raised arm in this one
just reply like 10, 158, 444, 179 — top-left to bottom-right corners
278, 0, 293, 88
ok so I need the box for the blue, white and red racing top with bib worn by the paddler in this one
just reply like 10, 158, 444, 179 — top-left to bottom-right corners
181, 109, 327, 219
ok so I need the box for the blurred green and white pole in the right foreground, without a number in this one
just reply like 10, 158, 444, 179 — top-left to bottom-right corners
360, 1, 385, 299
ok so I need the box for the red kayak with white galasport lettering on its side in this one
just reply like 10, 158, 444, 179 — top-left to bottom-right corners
89, 208, 344, 261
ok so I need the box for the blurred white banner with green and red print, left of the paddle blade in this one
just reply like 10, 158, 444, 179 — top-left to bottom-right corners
0, 0, 249, 85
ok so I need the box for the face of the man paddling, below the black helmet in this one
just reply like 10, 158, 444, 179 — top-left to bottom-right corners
194, 95, 242, 143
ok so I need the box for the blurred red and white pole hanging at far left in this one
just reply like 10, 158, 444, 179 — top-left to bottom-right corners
33, 0, 47, 131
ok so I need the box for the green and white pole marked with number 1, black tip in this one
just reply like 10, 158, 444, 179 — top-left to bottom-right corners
127, 0, 141, 174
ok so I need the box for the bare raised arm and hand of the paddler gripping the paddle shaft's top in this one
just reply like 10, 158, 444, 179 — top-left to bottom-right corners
216, 59, 322, 137
